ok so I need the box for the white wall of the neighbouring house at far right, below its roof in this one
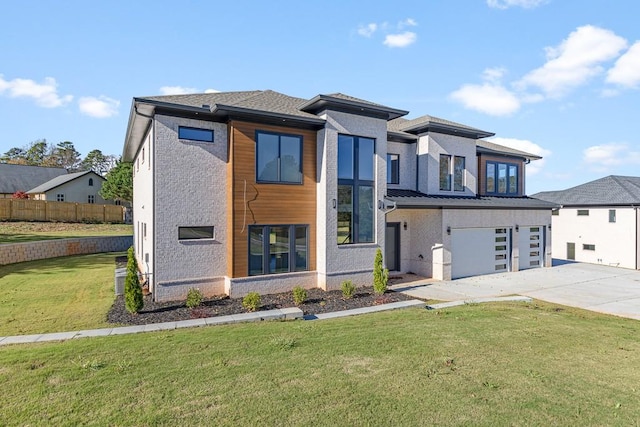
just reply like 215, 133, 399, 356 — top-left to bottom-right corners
552, 207, 638, 269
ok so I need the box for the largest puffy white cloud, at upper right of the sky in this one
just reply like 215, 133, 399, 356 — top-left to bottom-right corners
516, 25, 627, 98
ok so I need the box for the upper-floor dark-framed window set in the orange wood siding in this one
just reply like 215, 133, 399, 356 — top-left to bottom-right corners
256, 131, 302, 184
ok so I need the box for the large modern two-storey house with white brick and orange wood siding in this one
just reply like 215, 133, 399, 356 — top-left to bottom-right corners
123, 91, 555, 300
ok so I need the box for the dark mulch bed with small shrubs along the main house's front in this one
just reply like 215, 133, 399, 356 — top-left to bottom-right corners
107, 288, 412, 325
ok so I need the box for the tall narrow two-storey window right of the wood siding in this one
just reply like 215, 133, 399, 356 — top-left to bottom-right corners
338, 135, 375, 245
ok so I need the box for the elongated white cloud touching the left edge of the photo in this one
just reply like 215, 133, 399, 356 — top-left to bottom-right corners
0, 74, 73, 108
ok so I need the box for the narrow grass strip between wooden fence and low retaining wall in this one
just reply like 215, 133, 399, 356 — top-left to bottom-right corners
0, 221, 133, 244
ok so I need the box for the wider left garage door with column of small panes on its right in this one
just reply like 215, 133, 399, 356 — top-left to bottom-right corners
451, 228, 511, 279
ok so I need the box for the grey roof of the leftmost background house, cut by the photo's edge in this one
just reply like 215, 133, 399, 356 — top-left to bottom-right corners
0, 163, 67, 199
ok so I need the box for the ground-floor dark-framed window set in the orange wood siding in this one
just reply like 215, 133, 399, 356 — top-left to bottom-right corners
249, 225, 309, 276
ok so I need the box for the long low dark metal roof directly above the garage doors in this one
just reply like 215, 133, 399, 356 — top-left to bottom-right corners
387, 188, 558, 210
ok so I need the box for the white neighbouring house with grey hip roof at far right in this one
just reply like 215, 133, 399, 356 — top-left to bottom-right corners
533, 175, 640, 270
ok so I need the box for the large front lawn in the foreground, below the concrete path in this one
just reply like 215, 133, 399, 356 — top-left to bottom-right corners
0, 303, 640, 426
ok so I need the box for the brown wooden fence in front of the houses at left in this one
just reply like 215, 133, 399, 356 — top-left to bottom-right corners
0, 199, 124, 223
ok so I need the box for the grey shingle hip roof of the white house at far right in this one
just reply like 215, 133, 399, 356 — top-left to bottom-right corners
531, 175, 640, 206
